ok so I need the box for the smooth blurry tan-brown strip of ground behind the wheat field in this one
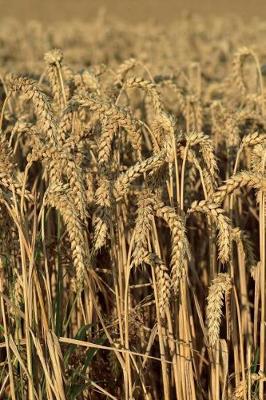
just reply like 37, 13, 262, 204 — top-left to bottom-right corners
0, 0, 266, 23
